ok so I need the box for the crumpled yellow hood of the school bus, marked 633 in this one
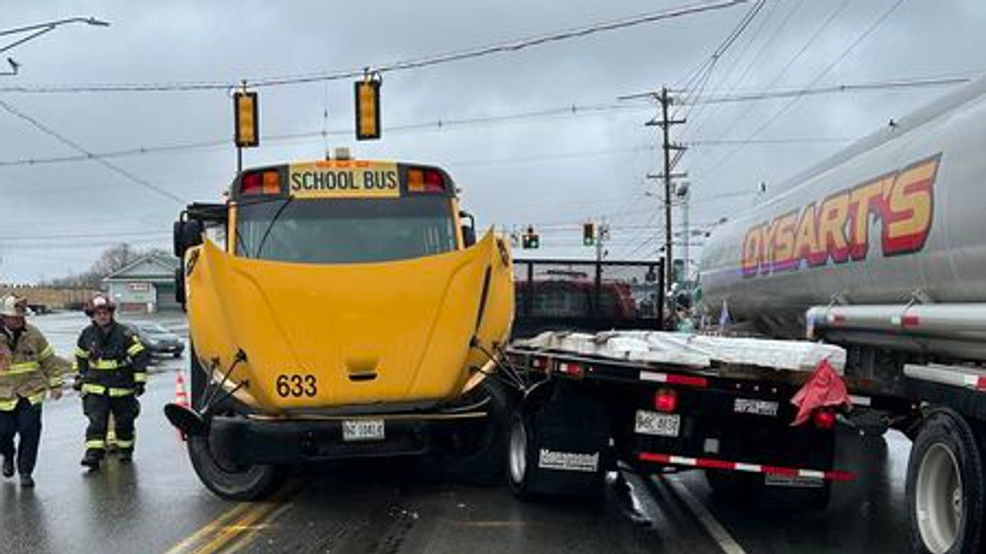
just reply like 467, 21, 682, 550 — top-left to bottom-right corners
186, 231, 514, 413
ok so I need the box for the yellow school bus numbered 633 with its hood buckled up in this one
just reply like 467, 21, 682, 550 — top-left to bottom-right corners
166, 159, 514, 499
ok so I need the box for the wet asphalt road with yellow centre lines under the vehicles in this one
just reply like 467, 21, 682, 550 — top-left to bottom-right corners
0, 314, 910, 554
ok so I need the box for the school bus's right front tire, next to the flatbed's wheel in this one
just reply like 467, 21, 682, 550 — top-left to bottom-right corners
436, 377, 513, 486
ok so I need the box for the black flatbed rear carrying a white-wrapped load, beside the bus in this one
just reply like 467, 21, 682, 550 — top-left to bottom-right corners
507, 331, 916, 509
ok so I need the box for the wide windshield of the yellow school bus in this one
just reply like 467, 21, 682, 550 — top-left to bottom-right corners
236, 196, 456, 264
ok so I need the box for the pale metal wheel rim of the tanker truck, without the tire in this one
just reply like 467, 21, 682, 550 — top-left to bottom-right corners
915, 443, 963, 554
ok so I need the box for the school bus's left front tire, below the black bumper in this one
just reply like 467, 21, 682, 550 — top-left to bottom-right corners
188, 436, 280, 500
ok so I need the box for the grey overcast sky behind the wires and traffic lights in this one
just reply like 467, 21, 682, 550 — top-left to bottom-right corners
0, 0, 986, 282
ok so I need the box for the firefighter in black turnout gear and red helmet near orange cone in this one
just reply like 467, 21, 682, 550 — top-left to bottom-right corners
75, 295, 149, 469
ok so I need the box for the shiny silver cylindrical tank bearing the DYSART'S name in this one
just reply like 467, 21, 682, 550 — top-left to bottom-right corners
701, 74, 986, 358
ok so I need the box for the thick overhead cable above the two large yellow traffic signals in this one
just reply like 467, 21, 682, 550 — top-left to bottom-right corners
0, 0, 752, 94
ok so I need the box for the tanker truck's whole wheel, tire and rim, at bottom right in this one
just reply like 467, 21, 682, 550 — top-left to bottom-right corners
906, 409, 986, 554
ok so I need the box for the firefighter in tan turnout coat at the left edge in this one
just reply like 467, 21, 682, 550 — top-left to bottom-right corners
0, 295, 68, 487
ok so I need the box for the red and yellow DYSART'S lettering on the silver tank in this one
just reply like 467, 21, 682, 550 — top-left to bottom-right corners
743, 154, 941, 277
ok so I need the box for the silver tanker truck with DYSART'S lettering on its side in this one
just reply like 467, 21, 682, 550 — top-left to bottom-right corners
701, 74, 986, 554
